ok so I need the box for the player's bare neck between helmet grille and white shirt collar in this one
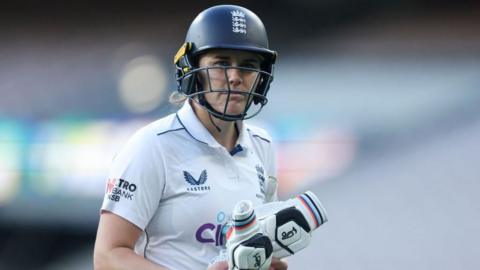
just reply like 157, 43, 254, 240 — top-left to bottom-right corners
191, 102, 238, 151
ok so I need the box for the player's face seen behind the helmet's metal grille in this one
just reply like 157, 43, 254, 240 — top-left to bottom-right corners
199, 50, 261, 115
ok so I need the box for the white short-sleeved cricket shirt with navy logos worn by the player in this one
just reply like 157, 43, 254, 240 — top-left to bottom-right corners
102, 101, 276, 270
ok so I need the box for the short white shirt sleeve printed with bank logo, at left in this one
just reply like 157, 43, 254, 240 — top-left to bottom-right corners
101, 127, 165, 230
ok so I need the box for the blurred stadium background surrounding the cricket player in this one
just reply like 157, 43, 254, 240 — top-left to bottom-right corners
0, 0, 480, 270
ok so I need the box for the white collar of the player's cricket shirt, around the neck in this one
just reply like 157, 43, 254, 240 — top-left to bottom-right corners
177, 100, 248, 149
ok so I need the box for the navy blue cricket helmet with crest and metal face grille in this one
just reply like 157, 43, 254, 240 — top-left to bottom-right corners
174, 5, 277, 121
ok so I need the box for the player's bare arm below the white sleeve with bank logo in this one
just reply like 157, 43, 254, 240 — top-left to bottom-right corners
93, 211, 166, 270
